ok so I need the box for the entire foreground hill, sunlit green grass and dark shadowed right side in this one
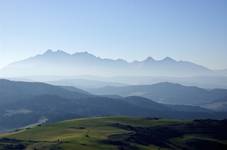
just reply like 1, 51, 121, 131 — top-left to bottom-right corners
0, 117, 227, 150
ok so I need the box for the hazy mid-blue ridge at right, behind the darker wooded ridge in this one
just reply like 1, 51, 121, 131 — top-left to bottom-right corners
90, 82, 227, 105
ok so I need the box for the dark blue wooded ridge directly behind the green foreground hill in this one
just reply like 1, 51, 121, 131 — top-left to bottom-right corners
0, 80, 225, 131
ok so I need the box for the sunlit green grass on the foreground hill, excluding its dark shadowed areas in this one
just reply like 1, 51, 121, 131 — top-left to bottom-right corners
0, 117, 226, 150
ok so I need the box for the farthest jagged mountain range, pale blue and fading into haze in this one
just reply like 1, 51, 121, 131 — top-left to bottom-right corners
1, 50, 213, 76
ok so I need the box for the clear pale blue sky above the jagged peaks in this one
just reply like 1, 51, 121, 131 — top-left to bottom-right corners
0, 0, 227, 69
